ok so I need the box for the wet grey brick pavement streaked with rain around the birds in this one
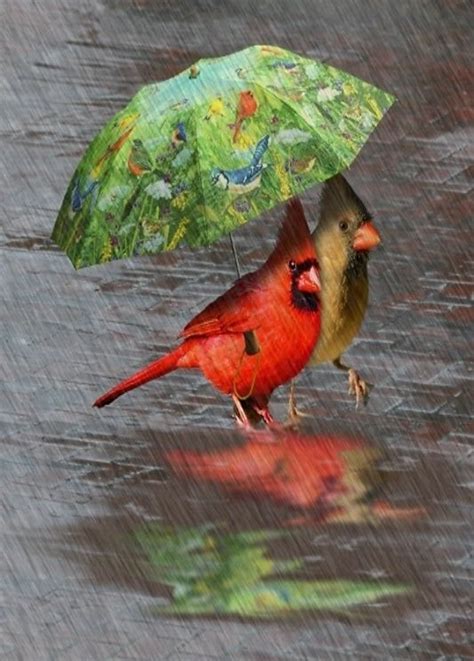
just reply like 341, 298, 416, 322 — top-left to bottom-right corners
0, 0, 474, 661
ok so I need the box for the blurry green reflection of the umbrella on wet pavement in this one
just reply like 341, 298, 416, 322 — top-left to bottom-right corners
136, 524, 409, 618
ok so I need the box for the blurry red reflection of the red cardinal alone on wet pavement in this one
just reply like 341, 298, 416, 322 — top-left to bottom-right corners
166, 432, 362, 507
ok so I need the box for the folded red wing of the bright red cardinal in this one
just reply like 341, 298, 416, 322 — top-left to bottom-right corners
180, 274, 261, 338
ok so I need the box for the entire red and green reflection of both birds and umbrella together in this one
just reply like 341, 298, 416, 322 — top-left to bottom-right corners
127, 431, 424, 618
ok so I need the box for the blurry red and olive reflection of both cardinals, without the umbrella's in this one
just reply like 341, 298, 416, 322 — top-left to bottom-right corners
166, 431, 424, 525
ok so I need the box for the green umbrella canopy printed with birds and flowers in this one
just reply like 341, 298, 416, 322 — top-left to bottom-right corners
52, 46, 394, 268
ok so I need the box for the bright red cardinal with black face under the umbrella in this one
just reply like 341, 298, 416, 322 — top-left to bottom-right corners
94, 200, 320, 425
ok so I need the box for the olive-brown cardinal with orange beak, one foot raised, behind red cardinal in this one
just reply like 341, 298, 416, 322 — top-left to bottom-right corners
289, 174, 381, 419
